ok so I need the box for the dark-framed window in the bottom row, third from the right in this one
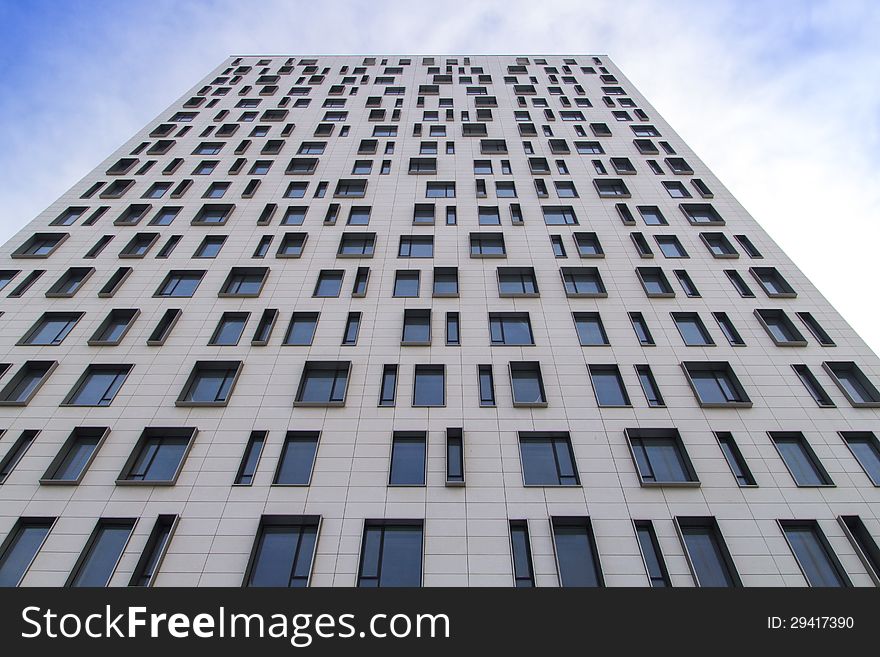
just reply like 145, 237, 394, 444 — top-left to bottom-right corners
675, 516, 742, 587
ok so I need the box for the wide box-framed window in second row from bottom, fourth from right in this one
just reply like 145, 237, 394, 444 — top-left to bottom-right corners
626, 429, 700, 486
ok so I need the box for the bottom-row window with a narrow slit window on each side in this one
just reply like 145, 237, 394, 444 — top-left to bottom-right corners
550, 516, 605, 587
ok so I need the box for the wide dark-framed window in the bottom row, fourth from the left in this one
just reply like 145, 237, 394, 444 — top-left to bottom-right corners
244, 515, 320, 588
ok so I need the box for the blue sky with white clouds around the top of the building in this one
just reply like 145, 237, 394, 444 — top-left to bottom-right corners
0, 0, 880, 351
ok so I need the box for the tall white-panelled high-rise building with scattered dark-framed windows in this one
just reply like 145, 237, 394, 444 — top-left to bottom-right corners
0, 55, 880, 587
